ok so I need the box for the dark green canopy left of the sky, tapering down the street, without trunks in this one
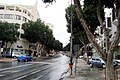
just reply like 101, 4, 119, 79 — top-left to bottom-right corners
23, 19, 62, 50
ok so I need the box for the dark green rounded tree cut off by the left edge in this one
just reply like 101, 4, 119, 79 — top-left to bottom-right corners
0, 22, 19, 48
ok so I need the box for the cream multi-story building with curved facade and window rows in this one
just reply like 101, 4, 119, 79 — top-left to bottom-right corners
0, 4, 39, 53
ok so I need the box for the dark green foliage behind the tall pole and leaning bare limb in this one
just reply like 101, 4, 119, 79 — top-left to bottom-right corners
66, 4, 104, 57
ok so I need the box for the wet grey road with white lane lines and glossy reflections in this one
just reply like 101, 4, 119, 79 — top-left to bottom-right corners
0, 55, 69, 80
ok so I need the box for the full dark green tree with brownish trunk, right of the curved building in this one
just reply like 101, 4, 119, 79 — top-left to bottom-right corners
22, 19, 61, 55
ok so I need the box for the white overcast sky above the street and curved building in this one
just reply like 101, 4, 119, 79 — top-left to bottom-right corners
0, 0, 70, 45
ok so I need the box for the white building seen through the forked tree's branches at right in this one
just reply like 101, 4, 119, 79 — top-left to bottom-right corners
96, 9, 120, 59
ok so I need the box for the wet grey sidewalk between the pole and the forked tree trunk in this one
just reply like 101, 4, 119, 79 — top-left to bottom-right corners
63, 59, 104, 80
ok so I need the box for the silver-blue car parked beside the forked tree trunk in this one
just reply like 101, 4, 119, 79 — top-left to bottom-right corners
88, 58, 105, 68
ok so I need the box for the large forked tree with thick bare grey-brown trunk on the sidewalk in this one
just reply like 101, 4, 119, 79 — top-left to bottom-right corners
74, 0, 120, 80
